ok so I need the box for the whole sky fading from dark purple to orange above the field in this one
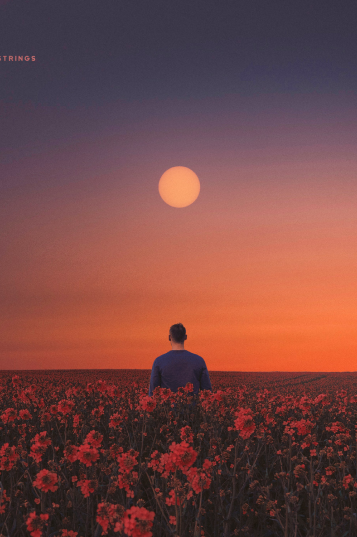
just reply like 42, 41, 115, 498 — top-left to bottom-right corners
0, 0, 357, 371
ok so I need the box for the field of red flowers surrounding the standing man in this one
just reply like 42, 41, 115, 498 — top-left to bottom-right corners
0, 370, 357, 537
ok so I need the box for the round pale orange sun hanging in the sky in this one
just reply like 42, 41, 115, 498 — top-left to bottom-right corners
159, 166, 200, 207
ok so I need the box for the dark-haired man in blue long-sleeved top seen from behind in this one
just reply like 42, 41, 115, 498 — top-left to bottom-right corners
149, 323, 212, 395
